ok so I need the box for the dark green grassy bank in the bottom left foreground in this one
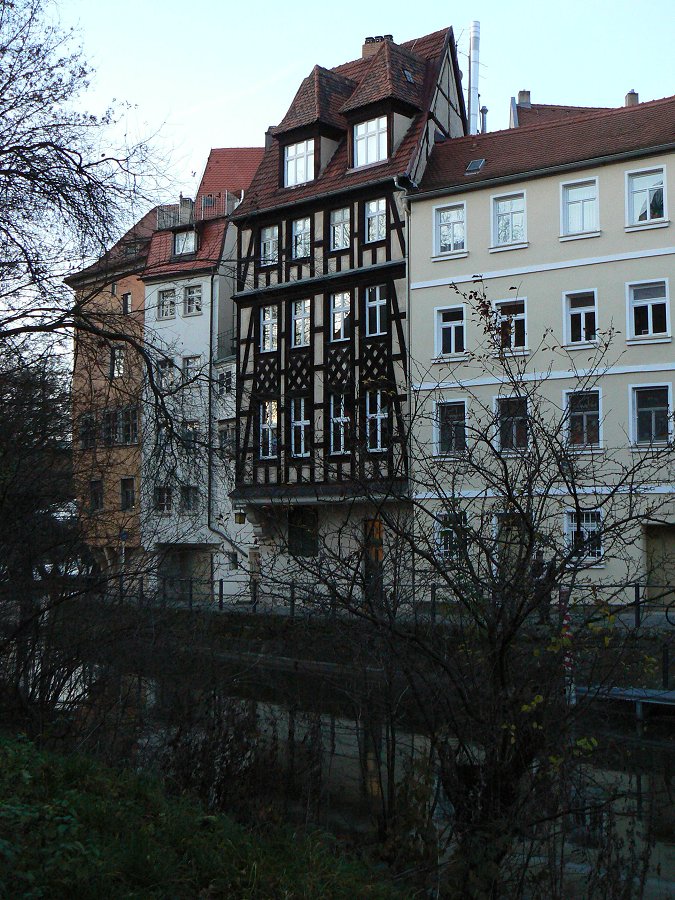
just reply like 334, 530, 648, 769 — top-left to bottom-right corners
0, 738, 403, 900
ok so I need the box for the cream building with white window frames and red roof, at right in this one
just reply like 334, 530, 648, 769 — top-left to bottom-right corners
408, 93, 675, 597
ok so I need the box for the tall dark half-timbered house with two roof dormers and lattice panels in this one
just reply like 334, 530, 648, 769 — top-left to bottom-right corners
233, 29, 466, 580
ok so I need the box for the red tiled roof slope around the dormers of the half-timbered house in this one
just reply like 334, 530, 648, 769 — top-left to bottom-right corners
233, 29, 452, 219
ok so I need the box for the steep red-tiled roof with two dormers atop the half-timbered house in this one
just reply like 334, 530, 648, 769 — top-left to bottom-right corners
233, 29, 454, 219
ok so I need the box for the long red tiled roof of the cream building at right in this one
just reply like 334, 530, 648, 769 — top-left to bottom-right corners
421, 97, 675, 191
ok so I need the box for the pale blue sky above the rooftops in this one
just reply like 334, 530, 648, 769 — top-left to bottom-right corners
56, 0, 675, 194
